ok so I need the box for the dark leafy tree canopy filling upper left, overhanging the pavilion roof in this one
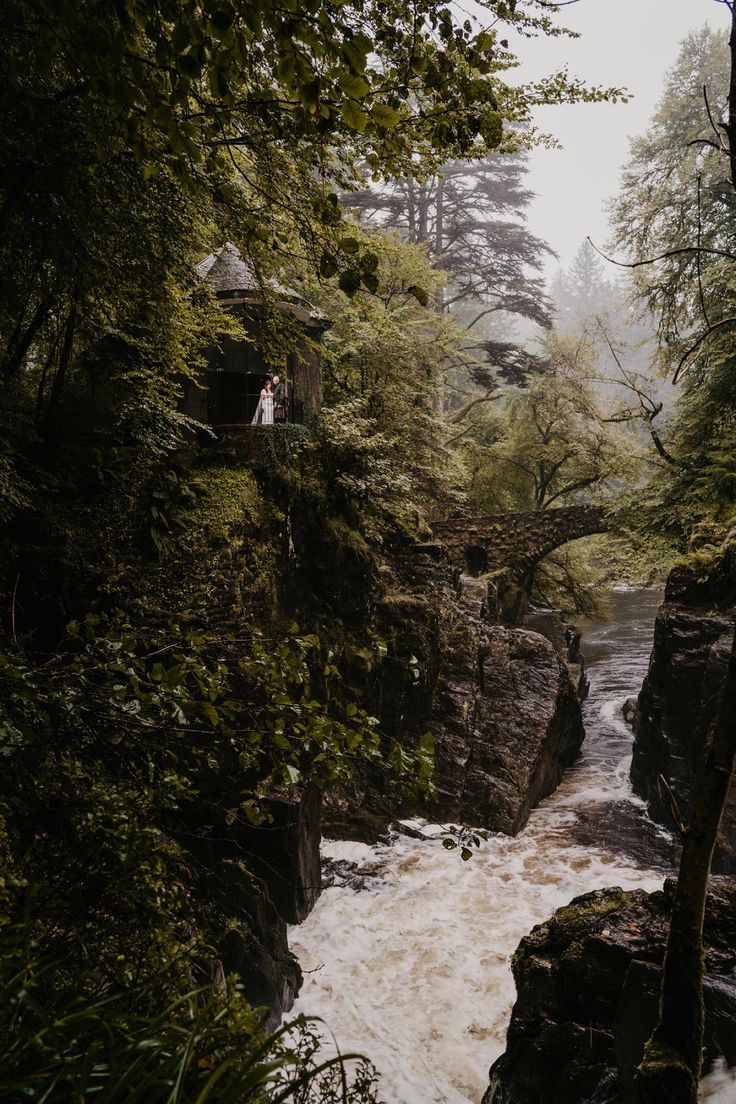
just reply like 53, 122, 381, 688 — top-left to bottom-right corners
0, 0, 631, 490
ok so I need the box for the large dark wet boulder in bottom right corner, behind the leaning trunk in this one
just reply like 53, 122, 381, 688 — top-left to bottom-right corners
483, 878, 736, 1104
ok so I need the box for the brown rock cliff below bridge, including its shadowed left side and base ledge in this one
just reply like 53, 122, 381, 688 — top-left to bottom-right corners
326, 545, 585, 839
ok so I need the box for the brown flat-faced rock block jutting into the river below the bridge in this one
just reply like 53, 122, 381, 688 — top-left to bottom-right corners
433, 576, 584, 835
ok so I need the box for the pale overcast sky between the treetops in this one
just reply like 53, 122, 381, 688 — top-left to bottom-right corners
516, 0, 728, 272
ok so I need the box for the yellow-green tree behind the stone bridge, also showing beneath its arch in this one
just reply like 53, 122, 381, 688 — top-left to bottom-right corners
457, 330, 641, 617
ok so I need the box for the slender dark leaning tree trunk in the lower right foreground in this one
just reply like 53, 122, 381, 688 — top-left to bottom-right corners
638, 634, 736, 1104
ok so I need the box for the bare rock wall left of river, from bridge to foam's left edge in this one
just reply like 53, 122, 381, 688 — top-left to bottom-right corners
244, 529, 585, 1017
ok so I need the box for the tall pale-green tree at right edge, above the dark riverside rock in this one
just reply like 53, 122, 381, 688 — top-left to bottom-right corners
614, 28, 736, 562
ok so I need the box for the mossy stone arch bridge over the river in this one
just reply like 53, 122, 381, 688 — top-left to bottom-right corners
431, 506, 610, 580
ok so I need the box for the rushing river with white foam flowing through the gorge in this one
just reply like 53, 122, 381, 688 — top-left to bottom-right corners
291, 590, 736, 1104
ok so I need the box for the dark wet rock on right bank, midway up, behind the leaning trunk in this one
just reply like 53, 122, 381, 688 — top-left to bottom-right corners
631, 554, 736, 873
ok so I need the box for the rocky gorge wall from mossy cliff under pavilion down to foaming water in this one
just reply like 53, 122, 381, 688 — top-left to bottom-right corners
137, 443, 585, 1023
